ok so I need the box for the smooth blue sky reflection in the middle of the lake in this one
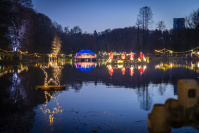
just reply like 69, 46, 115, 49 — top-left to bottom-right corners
33, 82, 176, 132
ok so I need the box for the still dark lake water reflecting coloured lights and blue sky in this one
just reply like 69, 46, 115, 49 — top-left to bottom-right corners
0, 61, 199, 133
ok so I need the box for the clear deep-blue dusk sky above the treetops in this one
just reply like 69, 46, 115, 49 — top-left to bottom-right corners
32, 0, 199, 33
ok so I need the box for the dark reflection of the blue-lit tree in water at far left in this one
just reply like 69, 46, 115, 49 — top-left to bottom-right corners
0, 64, 44, 132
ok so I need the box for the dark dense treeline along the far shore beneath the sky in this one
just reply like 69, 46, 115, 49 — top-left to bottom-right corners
0, 0, 199, 54
